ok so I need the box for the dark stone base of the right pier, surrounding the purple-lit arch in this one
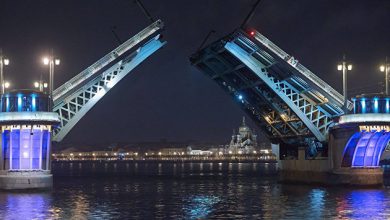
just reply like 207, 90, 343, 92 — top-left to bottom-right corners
279, 123, 383, 187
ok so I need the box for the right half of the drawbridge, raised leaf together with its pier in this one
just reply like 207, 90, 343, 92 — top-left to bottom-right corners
190, 29, 390, 185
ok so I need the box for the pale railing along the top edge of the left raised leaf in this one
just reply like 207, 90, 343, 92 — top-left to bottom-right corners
53, 20, 164, 102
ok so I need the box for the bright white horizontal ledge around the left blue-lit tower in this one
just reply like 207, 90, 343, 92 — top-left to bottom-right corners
0, 112, 60, 123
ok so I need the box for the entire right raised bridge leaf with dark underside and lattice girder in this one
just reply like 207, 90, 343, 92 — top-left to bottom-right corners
190, 30, 352, 145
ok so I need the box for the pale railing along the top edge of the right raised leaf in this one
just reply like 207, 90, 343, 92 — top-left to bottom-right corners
254, 31, 352, 109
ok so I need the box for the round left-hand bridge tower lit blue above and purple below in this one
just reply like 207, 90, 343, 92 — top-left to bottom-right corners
0, 90, 59, 189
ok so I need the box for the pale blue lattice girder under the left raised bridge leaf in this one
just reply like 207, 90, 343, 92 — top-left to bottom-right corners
53, 34, 166, 141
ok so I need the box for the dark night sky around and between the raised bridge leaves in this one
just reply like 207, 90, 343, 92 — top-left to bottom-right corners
0, 0, 390, 144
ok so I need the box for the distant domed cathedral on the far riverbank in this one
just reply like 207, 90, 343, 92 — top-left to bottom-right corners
228, 117, 257, 154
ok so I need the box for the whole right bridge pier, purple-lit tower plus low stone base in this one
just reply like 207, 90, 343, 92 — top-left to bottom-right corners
280, 95, 390, 186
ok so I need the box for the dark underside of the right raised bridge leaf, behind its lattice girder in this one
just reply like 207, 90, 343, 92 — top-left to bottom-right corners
193, 47, 312, 143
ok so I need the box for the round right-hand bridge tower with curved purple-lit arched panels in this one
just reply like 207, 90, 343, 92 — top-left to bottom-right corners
329, 94, 390, 185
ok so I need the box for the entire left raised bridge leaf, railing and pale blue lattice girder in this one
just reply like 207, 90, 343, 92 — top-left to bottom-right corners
53, 20, 166, 141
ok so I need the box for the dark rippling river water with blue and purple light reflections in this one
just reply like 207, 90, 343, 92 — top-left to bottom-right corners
0, 162, 390, 219
